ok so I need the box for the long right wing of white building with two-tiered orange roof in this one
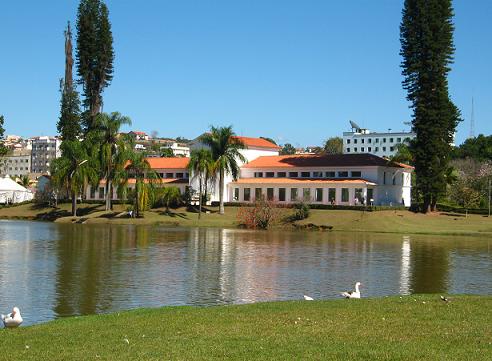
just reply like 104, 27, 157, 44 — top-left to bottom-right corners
226, 154, 412, 207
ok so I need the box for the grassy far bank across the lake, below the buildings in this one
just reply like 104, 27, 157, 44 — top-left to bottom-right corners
0, 204, 492, 237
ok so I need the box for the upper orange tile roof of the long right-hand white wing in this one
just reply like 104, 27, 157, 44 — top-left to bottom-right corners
243, 154, 403, 168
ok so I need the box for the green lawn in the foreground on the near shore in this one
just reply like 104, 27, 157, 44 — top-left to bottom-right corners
0, 295, 492, 360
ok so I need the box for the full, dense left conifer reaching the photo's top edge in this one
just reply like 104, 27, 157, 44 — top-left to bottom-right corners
76, 0, 114, 132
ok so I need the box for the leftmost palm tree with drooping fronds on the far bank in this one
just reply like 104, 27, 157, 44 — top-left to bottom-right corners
51, 140, 97, 217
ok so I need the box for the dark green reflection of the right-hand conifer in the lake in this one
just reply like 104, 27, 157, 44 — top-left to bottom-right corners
410, 240, 449, 293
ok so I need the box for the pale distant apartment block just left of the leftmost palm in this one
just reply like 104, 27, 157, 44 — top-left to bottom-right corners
31, 136, 61, 174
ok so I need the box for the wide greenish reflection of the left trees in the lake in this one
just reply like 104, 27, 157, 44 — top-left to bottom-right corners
55, 225, 142, 316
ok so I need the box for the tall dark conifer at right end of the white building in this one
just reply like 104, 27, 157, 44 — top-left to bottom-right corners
400, 0, 460, 212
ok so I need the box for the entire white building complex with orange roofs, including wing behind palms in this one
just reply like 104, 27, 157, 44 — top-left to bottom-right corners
86, 137, 413, 207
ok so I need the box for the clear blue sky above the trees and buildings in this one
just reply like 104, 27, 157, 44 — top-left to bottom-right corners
0, 0, 492, 146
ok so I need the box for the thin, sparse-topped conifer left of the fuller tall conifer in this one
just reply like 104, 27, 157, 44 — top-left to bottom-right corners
57, 22, 82, 141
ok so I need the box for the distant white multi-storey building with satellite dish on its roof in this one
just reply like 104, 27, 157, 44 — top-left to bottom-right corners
343, 122, 415, 157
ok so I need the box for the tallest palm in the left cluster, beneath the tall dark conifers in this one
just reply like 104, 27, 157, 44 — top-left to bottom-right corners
93, 112, 132, 211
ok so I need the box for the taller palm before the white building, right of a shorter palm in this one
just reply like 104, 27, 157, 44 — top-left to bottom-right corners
201, 126, 246, 214
